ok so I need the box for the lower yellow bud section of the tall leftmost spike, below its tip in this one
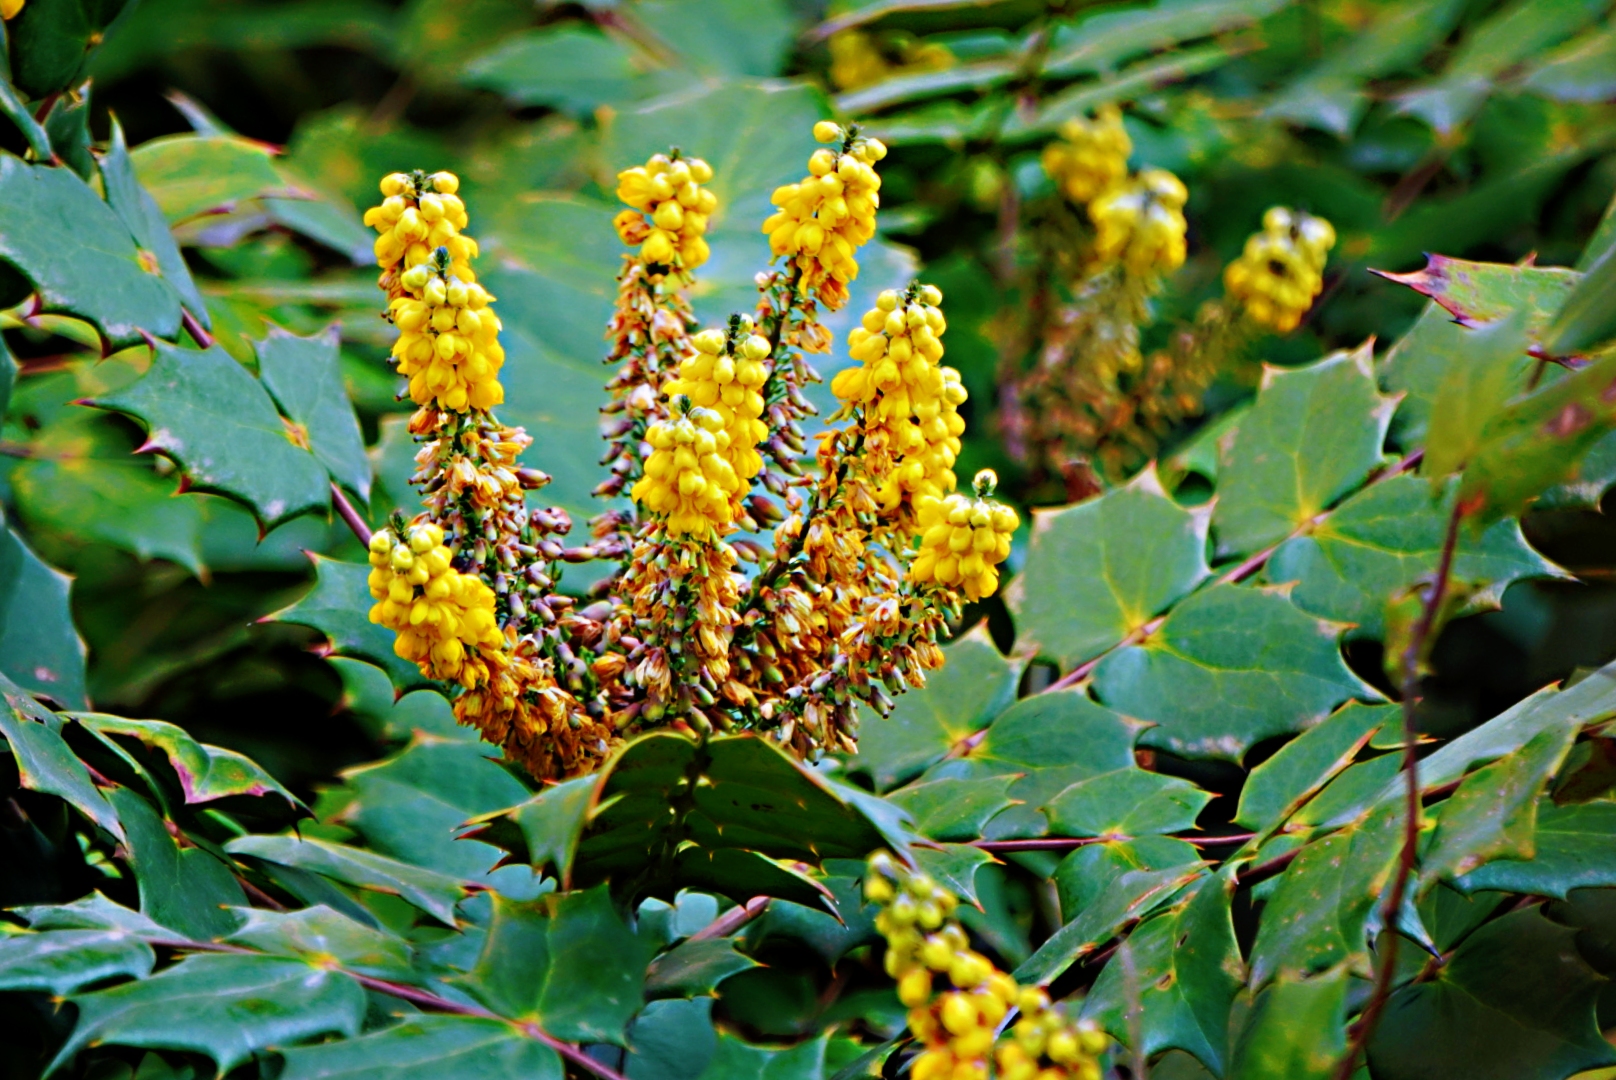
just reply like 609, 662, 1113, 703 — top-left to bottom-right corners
388, 258, 504, 412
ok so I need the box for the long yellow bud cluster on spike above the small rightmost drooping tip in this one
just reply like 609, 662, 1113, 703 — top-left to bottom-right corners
831, 285, 966, 513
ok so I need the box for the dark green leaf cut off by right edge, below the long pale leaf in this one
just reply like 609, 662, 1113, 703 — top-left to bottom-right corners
1453, 802, 1616, 897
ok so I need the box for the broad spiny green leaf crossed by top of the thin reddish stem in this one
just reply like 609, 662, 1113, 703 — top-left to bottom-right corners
1264, 474, 1561, 639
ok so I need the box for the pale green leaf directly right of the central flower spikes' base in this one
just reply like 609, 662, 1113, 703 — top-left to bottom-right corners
848, 624, 1021, 791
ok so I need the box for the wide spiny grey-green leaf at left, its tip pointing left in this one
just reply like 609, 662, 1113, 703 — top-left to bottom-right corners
94, 343, 331, 529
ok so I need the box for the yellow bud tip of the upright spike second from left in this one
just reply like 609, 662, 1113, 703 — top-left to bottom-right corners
612, 152, 718, 270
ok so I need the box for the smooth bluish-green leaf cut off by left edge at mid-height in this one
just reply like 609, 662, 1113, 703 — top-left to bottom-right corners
0, 511, 89, 708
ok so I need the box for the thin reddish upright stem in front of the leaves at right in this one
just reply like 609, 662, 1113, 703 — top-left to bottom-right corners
1335, 501, 1464, 1080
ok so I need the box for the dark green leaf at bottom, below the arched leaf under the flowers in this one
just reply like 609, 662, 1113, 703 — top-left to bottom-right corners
464, 884, 650, 1046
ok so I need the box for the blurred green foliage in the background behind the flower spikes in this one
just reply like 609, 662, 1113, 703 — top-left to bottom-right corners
0, 0, 1616, 794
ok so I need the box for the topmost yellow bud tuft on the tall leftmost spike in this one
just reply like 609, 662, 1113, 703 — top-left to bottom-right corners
365, 171, 477, 299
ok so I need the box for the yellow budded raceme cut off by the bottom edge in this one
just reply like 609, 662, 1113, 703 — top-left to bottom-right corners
865, 852, 1110, 1080
